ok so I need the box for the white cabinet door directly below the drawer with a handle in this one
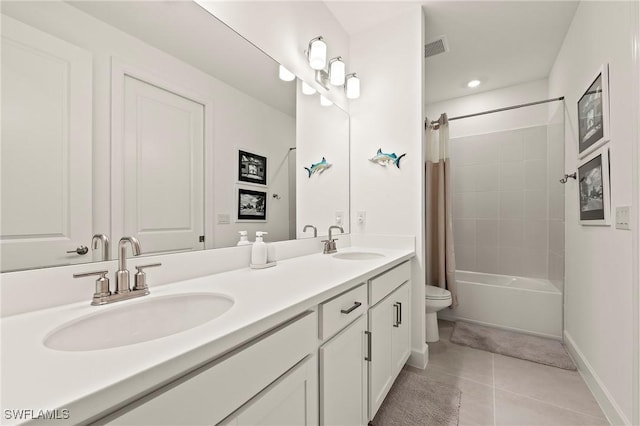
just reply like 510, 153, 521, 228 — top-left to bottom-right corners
320, 316, 368, 426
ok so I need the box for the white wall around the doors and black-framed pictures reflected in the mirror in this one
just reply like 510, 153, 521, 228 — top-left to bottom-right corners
3, 2, 295, 249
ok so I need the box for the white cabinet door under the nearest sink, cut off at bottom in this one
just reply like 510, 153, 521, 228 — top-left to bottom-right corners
236, 356, 318, 426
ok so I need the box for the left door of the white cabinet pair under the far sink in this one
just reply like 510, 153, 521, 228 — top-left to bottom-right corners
369, 296, 396, 419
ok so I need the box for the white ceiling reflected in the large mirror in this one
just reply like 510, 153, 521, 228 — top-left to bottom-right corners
69, 1, 296, 116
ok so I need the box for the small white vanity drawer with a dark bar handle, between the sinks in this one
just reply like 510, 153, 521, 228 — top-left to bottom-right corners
319, 284, 368, 340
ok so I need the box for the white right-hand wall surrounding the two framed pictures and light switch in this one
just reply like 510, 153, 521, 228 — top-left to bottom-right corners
549, 2, 638, 424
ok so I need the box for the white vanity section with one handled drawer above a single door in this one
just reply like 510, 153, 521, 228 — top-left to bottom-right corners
319, 284, 368, 426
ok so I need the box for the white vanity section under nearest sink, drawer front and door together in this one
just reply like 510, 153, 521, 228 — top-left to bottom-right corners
108, 312, 318, 425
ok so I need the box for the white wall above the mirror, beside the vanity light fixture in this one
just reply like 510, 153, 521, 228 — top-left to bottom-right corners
195, 0, 350, 110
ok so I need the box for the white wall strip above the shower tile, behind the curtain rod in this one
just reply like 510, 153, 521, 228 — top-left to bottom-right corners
426, 79, 548, 139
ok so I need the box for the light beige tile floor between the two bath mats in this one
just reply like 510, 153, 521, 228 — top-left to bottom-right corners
407, 321, 609, 426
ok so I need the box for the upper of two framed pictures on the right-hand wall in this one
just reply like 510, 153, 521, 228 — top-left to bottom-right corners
578, 64, 609, 158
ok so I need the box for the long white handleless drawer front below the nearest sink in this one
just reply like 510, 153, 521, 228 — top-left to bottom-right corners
111, 313, 317, 425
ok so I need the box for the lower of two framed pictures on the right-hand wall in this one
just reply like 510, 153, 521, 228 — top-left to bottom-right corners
578, 147, 611, 225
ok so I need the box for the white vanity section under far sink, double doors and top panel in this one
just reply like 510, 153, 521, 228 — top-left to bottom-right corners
368, 262, 411, 420
